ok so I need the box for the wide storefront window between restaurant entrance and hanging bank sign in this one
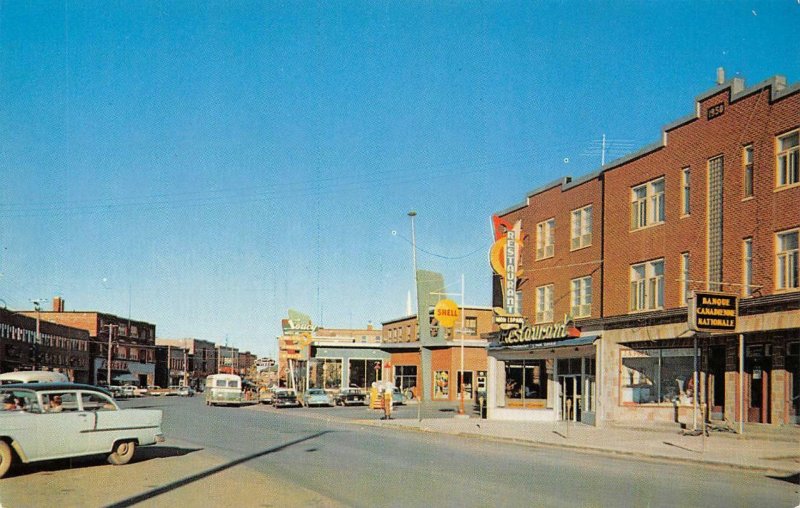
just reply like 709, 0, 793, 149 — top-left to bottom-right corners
621, 348, 694, 404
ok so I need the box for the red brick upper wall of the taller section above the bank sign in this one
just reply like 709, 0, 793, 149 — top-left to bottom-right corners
604, 85, 800, 316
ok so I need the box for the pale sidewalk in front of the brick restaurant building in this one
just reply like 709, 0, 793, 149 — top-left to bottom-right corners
358, 417, 800, 475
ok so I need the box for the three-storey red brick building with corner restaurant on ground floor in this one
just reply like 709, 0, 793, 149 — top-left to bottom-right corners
489, 72, 800, 425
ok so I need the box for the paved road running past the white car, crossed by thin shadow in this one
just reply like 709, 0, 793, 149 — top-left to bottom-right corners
0, 398, 800, 507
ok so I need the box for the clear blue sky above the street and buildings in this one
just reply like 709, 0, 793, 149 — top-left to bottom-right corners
0, 0, 800, 354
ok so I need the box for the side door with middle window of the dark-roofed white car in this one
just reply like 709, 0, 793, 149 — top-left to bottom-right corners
35, 390, 94, 459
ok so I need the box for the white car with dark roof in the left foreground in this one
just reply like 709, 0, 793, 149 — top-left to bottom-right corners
0, 383, 164, 477
